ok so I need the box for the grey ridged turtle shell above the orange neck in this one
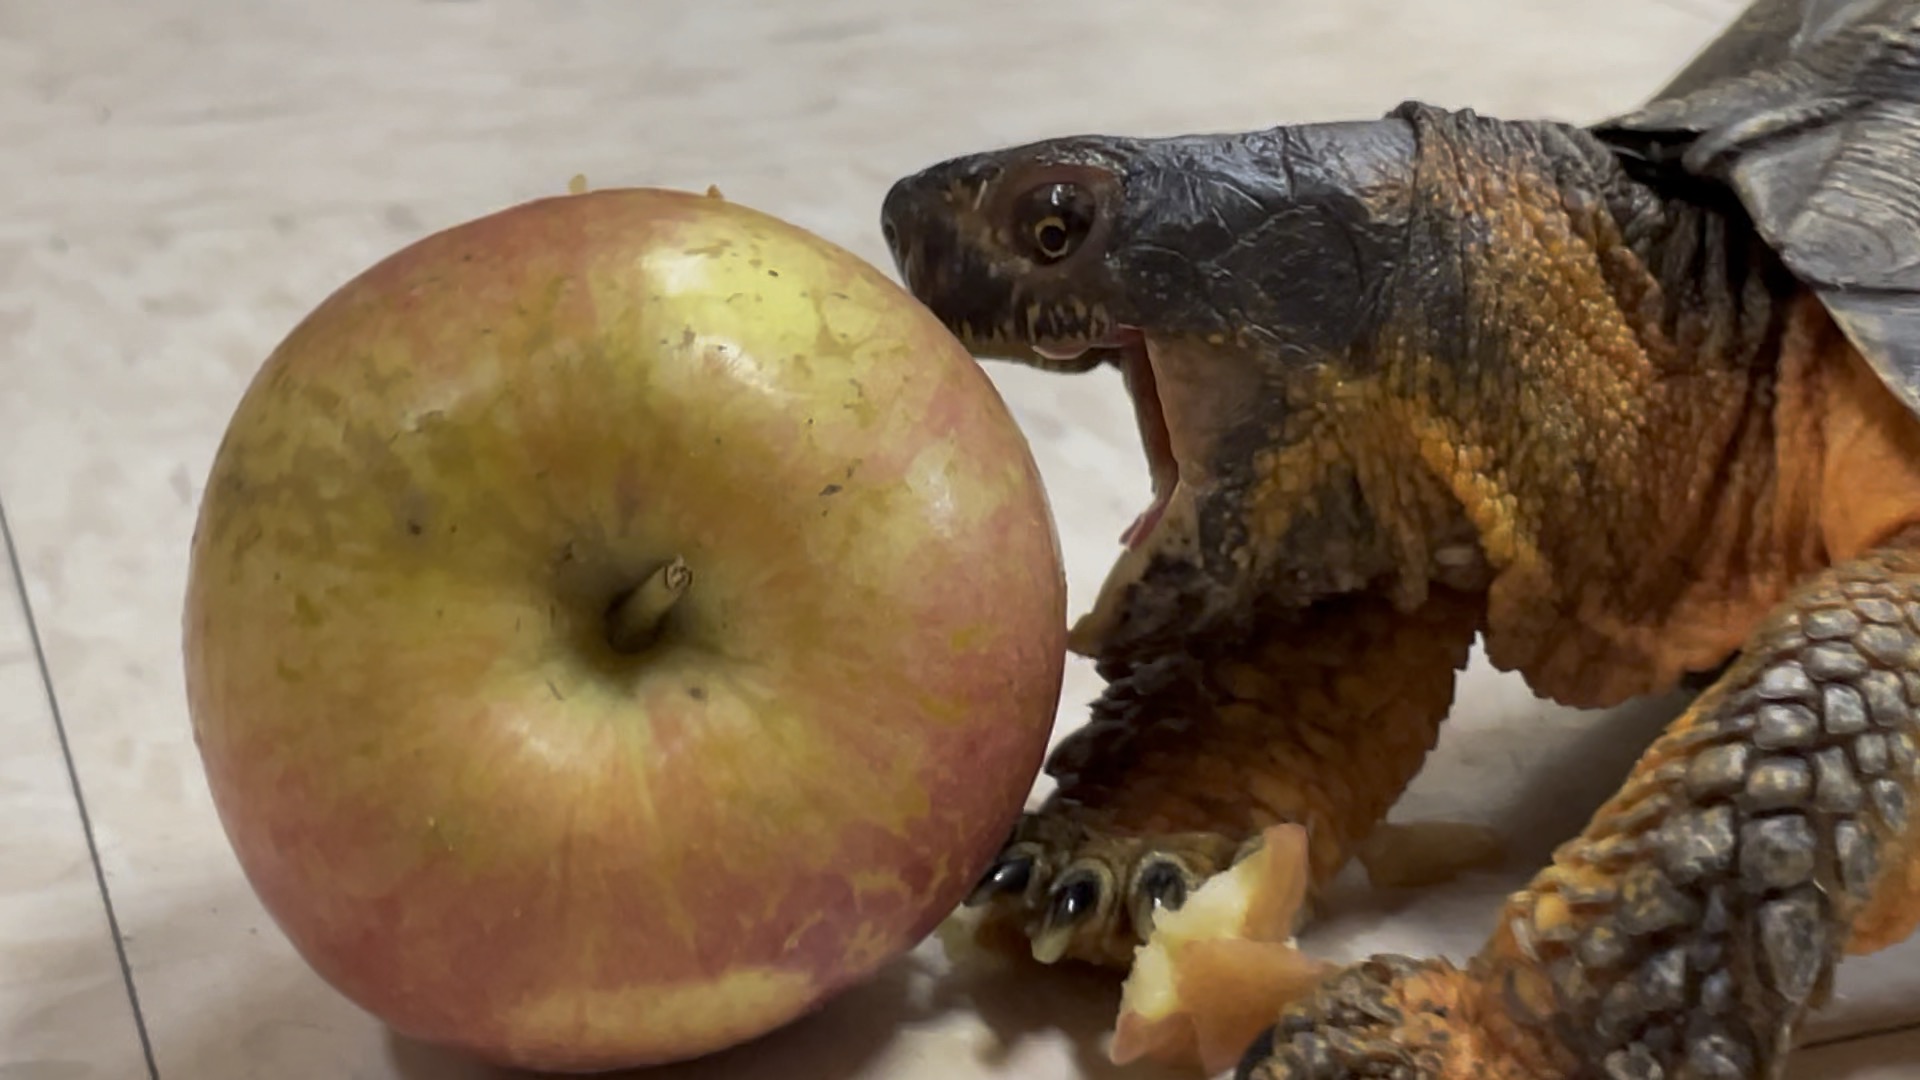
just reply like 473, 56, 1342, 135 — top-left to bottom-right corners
1594, 0, 1920, 413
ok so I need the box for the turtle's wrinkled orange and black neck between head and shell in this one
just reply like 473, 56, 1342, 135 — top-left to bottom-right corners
1336, 106, 1804, 705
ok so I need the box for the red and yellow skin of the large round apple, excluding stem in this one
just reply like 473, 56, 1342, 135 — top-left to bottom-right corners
184, 188, 1066, 1072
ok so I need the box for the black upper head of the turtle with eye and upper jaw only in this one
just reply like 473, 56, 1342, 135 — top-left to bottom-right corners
879, 119, 1413, 371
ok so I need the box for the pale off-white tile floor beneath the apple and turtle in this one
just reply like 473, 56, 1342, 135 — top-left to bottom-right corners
0, 0, 1920, 1080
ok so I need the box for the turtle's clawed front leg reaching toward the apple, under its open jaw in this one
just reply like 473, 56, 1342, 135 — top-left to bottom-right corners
973, 592, 1484, 967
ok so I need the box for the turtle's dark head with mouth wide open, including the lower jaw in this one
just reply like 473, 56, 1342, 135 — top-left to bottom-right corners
881, 117, 1415, 655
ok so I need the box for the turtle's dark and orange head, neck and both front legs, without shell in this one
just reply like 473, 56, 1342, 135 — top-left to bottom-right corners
885, 82, 1920, 1080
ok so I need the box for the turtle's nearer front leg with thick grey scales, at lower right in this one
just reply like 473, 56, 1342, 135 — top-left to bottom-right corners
1238, 536, 1920, 1080
